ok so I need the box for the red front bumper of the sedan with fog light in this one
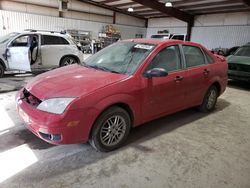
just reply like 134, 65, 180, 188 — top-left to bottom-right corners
16, 90, 88, 145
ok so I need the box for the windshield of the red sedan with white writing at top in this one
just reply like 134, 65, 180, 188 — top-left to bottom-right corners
83, 42, 155, 74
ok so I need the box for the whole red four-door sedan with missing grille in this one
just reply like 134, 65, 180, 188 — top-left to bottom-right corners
16, 39, 227, 151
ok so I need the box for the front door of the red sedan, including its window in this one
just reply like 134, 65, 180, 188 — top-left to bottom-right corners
142, 45, 186, 120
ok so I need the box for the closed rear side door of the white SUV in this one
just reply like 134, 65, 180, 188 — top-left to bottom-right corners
40, 35, 69, 68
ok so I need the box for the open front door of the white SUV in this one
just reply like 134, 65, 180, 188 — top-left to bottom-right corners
6, 35, 31, 71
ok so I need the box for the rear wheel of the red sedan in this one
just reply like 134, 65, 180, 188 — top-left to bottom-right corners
199, 85, 219, 112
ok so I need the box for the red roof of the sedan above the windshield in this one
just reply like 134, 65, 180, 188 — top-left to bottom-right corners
123, 38, 201, 46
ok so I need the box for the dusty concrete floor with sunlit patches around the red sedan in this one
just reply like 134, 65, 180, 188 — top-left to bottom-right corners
0, 77, 250, 188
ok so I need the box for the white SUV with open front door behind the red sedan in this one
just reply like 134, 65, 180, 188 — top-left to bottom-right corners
0, 30, 83, 77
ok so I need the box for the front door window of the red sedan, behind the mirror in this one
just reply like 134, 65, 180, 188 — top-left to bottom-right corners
148, 46, 181, 72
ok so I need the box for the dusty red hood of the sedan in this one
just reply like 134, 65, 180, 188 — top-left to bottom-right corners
26, 65, 128, 99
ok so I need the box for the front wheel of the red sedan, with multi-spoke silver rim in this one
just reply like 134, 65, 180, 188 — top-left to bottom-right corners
89, 107, 131, 152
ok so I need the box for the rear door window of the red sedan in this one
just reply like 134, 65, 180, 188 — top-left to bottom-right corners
183, 45, 206, 67
